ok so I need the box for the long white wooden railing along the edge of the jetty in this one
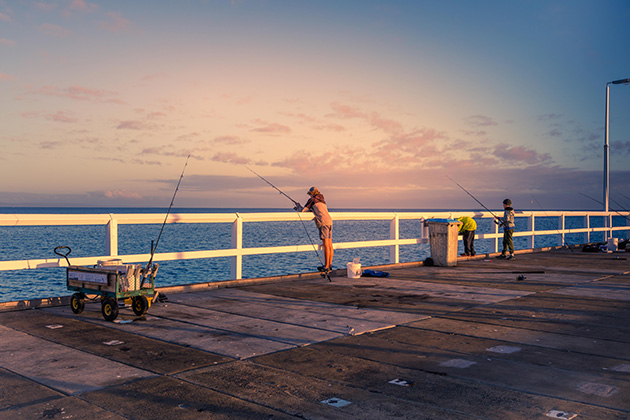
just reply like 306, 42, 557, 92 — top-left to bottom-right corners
0, 211, 630, 279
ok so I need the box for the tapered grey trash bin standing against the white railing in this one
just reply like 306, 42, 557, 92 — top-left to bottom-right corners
424, 219, 462, 267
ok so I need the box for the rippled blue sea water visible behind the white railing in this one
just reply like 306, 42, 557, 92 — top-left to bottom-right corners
0, 207, 627, 302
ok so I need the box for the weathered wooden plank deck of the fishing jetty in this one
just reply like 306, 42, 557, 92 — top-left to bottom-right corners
0, 249, 630, 420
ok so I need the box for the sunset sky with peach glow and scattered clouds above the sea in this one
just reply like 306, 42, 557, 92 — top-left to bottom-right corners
0, 0, 630, 210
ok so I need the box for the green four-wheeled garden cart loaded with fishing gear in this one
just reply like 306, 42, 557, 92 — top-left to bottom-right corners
54, 246, 159, 321
